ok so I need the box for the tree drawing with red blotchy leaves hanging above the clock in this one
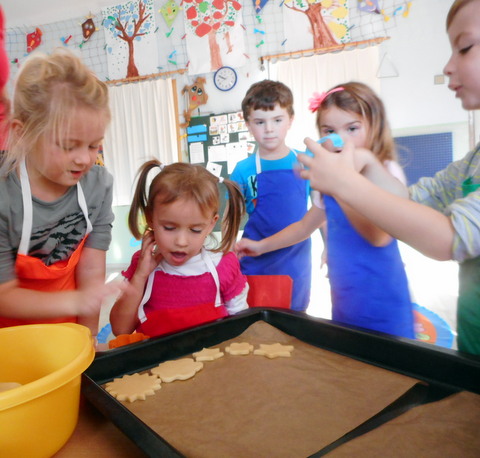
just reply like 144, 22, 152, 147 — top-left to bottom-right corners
184, 0, 242, 71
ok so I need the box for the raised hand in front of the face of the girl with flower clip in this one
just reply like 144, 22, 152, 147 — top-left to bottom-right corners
298, 138, 355, 194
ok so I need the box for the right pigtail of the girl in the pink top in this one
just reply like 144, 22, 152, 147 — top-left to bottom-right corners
219, 179, 245, 253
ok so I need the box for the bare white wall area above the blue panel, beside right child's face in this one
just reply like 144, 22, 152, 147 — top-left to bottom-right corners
380, 0, 467, 129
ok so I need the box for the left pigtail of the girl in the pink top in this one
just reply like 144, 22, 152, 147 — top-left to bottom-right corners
128, 159, 162, 240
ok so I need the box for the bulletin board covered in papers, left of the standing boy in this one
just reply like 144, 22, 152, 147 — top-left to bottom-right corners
187, 111, 257, 231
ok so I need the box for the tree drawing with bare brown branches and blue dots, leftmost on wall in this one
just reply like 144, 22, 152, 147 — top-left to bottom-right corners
103, 0, 154, 78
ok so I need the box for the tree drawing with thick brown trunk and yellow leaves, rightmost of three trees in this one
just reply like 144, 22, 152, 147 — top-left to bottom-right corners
283, 0, 350, 51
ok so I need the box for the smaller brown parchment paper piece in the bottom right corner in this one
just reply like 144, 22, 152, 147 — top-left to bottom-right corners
328, 391, 480, 458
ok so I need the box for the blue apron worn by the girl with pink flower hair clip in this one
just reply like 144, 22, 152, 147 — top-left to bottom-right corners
324, 196, 415, 339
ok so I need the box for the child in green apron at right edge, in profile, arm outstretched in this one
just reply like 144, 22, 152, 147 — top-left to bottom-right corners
299, 0, 480, 355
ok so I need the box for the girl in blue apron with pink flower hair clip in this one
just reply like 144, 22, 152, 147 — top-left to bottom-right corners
237, 82, 414, 338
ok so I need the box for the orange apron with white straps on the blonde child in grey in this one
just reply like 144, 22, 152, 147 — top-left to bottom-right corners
0, 162, 92, 327
